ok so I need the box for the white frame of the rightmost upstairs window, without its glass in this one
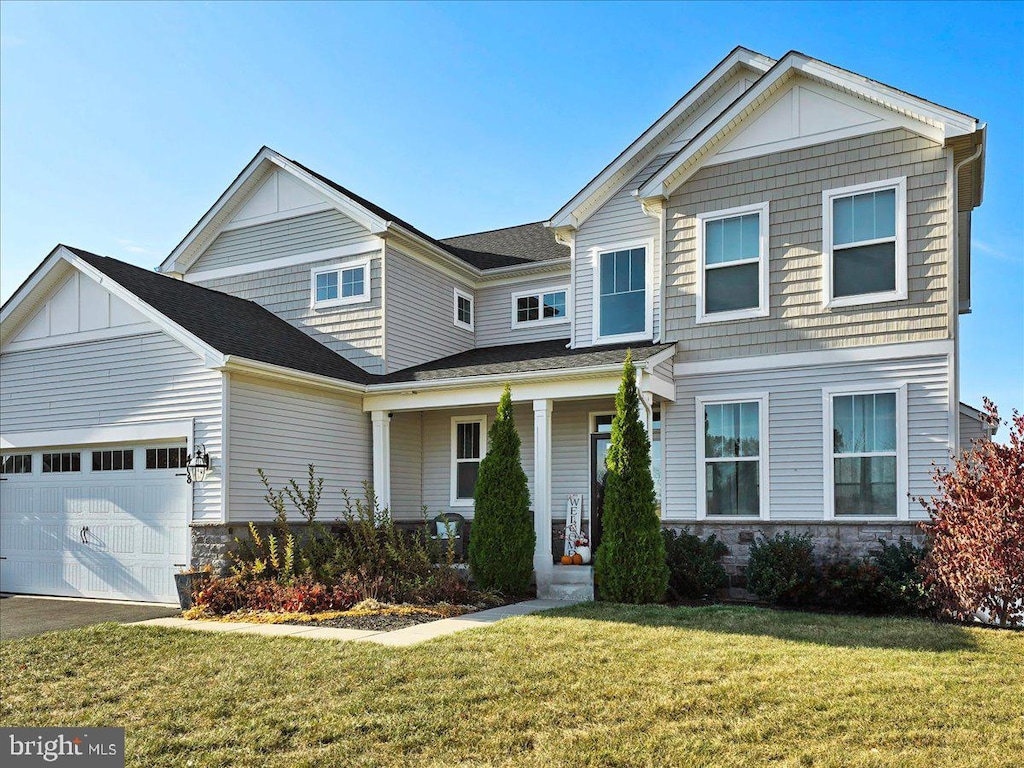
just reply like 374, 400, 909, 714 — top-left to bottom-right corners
821, 176, 907, 308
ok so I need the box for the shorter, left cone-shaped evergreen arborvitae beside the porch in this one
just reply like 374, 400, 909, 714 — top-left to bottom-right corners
469, 384, 537, 595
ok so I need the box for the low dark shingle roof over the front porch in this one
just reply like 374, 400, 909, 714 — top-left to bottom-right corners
379, 339, 672, 384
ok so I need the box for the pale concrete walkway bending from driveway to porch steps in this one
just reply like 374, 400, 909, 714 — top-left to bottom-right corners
133, 600, 580, 646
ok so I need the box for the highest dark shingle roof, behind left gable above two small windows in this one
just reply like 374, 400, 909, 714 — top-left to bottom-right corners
280, 152, 569, 269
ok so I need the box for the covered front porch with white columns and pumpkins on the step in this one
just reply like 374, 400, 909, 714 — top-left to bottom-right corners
364, 345, 675, 597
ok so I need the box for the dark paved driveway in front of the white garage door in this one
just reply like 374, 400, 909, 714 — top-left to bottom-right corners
0, 595, 179, 640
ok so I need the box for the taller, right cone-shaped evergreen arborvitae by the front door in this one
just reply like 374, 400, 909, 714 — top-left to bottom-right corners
594, 352, 669, 603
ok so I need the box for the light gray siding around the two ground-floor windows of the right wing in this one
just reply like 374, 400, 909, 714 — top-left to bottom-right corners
663, 356, 949, 520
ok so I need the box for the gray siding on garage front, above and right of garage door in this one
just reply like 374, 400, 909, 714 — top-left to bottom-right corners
0, 332, 223, 520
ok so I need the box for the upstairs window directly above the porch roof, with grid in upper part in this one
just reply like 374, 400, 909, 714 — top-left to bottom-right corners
594, 245, 652, 341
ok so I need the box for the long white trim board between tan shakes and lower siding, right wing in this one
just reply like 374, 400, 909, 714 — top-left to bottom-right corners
673, 339, 952, 376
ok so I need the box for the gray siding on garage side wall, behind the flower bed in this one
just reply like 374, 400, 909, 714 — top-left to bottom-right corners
227, 374, 373, 522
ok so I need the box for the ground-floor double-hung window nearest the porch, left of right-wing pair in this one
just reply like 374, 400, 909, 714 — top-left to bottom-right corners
696, 394, 768, 518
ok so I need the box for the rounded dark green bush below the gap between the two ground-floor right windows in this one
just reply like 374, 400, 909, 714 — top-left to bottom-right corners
746, 531, 817, 605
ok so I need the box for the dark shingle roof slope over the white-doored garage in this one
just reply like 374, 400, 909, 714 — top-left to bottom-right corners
68, 247, 378, 384
